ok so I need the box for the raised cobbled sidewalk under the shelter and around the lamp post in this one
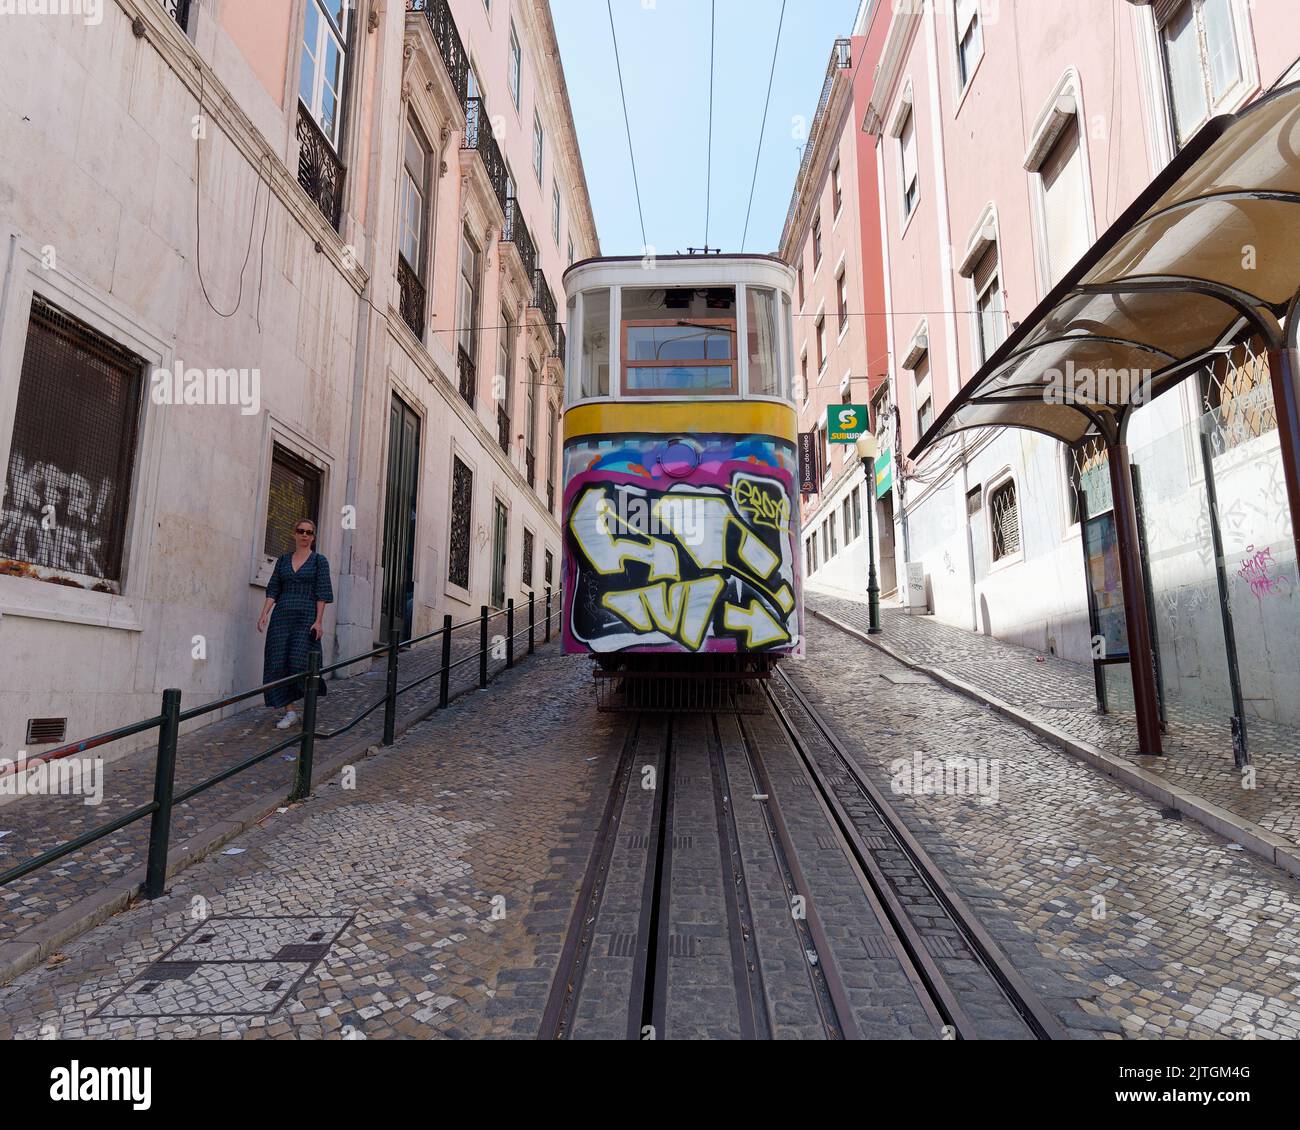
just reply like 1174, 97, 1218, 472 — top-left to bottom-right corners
805, 590, 1300, 844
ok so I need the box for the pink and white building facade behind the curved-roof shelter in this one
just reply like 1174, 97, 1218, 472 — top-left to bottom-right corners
861, 0, 1300, 722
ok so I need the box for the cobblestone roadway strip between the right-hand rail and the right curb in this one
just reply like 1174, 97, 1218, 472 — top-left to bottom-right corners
790, 613, 1300, 1039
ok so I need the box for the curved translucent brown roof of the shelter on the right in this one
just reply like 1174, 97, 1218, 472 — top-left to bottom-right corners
911, 82, 1300, 458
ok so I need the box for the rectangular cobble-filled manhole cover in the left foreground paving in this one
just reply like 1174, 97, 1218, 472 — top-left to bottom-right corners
95, 915, 352, 1018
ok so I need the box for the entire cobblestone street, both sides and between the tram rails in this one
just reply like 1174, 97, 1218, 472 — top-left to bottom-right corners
0, 619, 1300, 1039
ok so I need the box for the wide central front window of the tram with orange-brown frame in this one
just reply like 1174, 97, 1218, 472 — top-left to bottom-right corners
621, 286, 737, 395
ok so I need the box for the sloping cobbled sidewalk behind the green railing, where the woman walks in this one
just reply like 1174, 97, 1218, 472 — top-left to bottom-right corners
0, 607, 559, 944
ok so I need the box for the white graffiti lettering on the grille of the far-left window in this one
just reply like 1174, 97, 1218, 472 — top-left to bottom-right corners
0, 451, 113, 579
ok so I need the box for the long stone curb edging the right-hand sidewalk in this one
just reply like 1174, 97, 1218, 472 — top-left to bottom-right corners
813, 609, 1300, 878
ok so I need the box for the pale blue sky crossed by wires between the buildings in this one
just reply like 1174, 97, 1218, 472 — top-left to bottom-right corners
551, 0, 858, 255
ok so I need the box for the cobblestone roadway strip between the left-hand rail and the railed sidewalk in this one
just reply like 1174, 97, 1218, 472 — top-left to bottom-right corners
0, 651, 623, 1039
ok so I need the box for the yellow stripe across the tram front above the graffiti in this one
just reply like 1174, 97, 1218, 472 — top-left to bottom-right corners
564, 401, 798, 443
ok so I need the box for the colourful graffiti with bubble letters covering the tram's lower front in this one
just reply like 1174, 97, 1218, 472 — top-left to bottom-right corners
564, 437, 801, 653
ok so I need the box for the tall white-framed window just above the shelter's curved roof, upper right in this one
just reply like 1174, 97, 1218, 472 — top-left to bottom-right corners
1153, 0, 1245, 147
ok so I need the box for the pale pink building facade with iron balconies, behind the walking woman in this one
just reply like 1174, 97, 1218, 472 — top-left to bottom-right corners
0, 0, 598, 757
